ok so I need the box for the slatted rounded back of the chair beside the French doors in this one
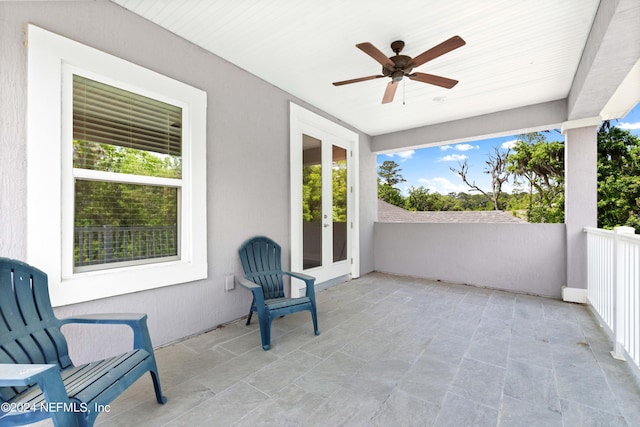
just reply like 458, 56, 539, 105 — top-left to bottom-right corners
239, 236, 284, 299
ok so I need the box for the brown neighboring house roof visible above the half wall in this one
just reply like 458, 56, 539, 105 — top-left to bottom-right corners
378, 200, 526, 223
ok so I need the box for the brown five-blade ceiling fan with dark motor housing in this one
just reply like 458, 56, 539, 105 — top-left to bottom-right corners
333, 36, 466, 104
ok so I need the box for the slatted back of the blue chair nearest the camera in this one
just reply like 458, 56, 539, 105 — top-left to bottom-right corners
0, 258, 71, 400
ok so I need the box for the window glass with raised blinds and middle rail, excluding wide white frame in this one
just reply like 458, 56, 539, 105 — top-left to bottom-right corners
73, 74, 182, 271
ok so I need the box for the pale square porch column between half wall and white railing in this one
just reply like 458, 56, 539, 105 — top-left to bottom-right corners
562, 117, 600, 289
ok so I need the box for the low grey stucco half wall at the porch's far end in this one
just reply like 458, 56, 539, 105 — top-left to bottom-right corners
374, 223, 566, 298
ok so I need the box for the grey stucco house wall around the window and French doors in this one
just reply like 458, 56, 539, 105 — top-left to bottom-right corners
0, 1, 376, 361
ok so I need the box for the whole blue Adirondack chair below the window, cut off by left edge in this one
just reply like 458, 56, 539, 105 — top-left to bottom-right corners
0, 258, 167, 427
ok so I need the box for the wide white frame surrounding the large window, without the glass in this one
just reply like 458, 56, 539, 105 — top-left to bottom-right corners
27, 25, 207, 306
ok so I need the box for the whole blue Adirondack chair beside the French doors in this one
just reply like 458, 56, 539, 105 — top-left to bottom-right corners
239, 236, 320, 350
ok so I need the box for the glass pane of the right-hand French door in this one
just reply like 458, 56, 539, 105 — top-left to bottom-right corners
331, 145, 347, 262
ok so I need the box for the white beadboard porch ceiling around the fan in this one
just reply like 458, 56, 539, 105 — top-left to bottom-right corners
113, 0, 599, 135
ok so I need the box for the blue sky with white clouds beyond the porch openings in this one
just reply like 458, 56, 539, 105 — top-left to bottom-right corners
377, 104, 640, 195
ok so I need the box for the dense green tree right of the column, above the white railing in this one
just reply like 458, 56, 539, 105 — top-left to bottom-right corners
598, 122, 640, 229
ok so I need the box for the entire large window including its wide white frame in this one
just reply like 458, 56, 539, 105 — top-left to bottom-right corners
27, 25, 207, 305
